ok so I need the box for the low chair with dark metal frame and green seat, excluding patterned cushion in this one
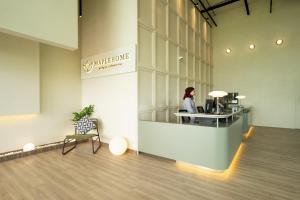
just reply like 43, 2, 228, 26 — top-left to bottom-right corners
62, 118, 101, 155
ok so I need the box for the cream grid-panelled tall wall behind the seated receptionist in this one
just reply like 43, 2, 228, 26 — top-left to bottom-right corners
138, 0, 212, 122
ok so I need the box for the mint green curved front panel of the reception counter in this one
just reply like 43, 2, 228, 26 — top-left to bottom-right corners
139, 117, 243, 170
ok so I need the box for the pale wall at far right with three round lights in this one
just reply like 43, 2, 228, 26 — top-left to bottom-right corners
212, 0, 300, 128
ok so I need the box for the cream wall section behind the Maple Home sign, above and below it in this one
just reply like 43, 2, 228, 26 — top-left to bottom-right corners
81, 0, 137, 149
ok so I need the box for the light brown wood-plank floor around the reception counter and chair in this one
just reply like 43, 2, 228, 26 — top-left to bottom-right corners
0, 127, 300, 200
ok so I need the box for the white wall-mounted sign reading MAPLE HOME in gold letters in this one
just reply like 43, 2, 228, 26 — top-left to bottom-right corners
81, 45, 136, 79
